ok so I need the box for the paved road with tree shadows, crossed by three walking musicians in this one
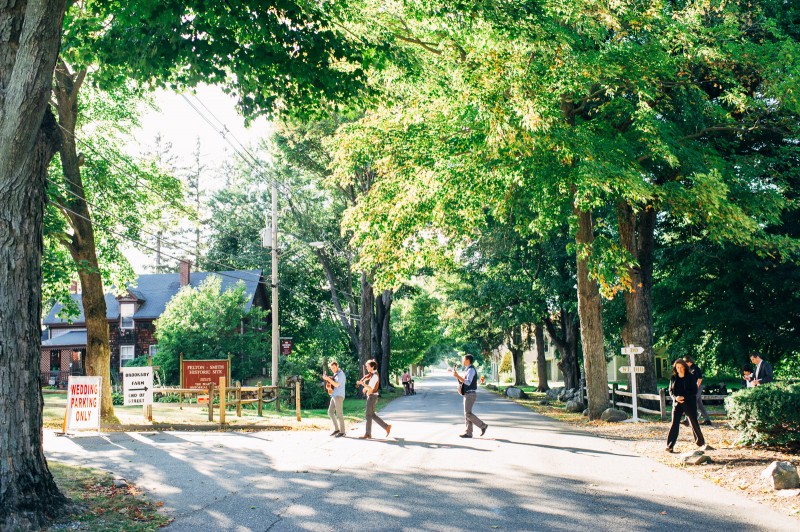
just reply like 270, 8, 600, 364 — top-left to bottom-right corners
45, 375, 800, 531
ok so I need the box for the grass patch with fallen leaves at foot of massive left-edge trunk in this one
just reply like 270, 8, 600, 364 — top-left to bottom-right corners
48, 461, 171, 532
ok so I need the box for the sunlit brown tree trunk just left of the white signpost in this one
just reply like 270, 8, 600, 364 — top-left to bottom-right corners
573, 207, 608, 420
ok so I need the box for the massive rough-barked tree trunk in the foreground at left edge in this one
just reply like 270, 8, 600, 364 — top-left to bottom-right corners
0, 0, 67, 530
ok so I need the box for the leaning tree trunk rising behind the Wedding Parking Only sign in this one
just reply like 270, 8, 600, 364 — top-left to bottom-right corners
54, 61, 114, 420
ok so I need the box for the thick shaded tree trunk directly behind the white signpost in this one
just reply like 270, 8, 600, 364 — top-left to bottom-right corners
617, 202, 657, 393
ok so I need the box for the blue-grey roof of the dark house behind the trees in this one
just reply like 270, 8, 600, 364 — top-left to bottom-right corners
42, 270, 261, 326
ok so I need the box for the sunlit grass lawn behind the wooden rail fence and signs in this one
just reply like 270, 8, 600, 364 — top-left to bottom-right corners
43, 388, 403, 431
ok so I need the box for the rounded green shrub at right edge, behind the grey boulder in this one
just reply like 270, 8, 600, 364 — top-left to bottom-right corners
725, 383, 800, 446
